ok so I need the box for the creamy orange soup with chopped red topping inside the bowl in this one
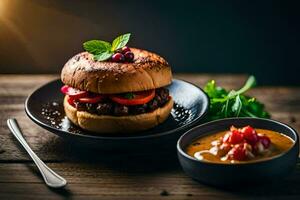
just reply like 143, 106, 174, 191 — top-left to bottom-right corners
185, 126, 294, 163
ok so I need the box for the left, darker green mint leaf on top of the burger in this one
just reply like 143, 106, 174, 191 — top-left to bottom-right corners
83, 40, 111, 55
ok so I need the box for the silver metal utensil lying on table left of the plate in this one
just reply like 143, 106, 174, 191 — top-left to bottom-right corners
7, 119, 67, 188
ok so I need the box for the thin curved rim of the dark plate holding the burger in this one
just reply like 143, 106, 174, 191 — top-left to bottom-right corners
25, 79, 210, 140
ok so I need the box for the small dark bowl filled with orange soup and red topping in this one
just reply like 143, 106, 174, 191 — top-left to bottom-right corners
177, 118, 299, 186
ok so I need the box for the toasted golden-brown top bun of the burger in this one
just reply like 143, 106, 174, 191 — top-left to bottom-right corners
61, 48, 172, 94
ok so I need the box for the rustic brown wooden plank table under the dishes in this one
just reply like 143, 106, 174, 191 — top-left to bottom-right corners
0, 74, 300, 200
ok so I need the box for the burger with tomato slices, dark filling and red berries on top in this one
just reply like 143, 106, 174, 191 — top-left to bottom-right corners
61, 33, 173, 133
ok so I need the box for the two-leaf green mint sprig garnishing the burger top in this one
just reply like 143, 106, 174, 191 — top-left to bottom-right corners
83, 33, 131, 61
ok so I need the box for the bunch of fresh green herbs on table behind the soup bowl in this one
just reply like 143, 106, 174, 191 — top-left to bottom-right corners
204, 76, 270, 120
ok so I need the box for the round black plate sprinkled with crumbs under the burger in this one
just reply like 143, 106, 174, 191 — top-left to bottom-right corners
25, 79, 209, 149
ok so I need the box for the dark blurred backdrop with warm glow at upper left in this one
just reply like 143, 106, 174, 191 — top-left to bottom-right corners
0, 0, 300, 85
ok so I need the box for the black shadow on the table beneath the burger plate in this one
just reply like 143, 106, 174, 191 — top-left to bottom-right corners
39, 138, 180, 173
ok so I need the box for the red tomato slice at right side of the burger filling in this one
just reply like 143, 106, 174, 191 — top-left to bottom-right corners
110, 90, 155, 106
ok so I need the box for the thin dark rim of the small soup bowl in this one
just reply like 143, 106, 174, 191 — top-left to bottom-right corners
176, 117, 299, 166
